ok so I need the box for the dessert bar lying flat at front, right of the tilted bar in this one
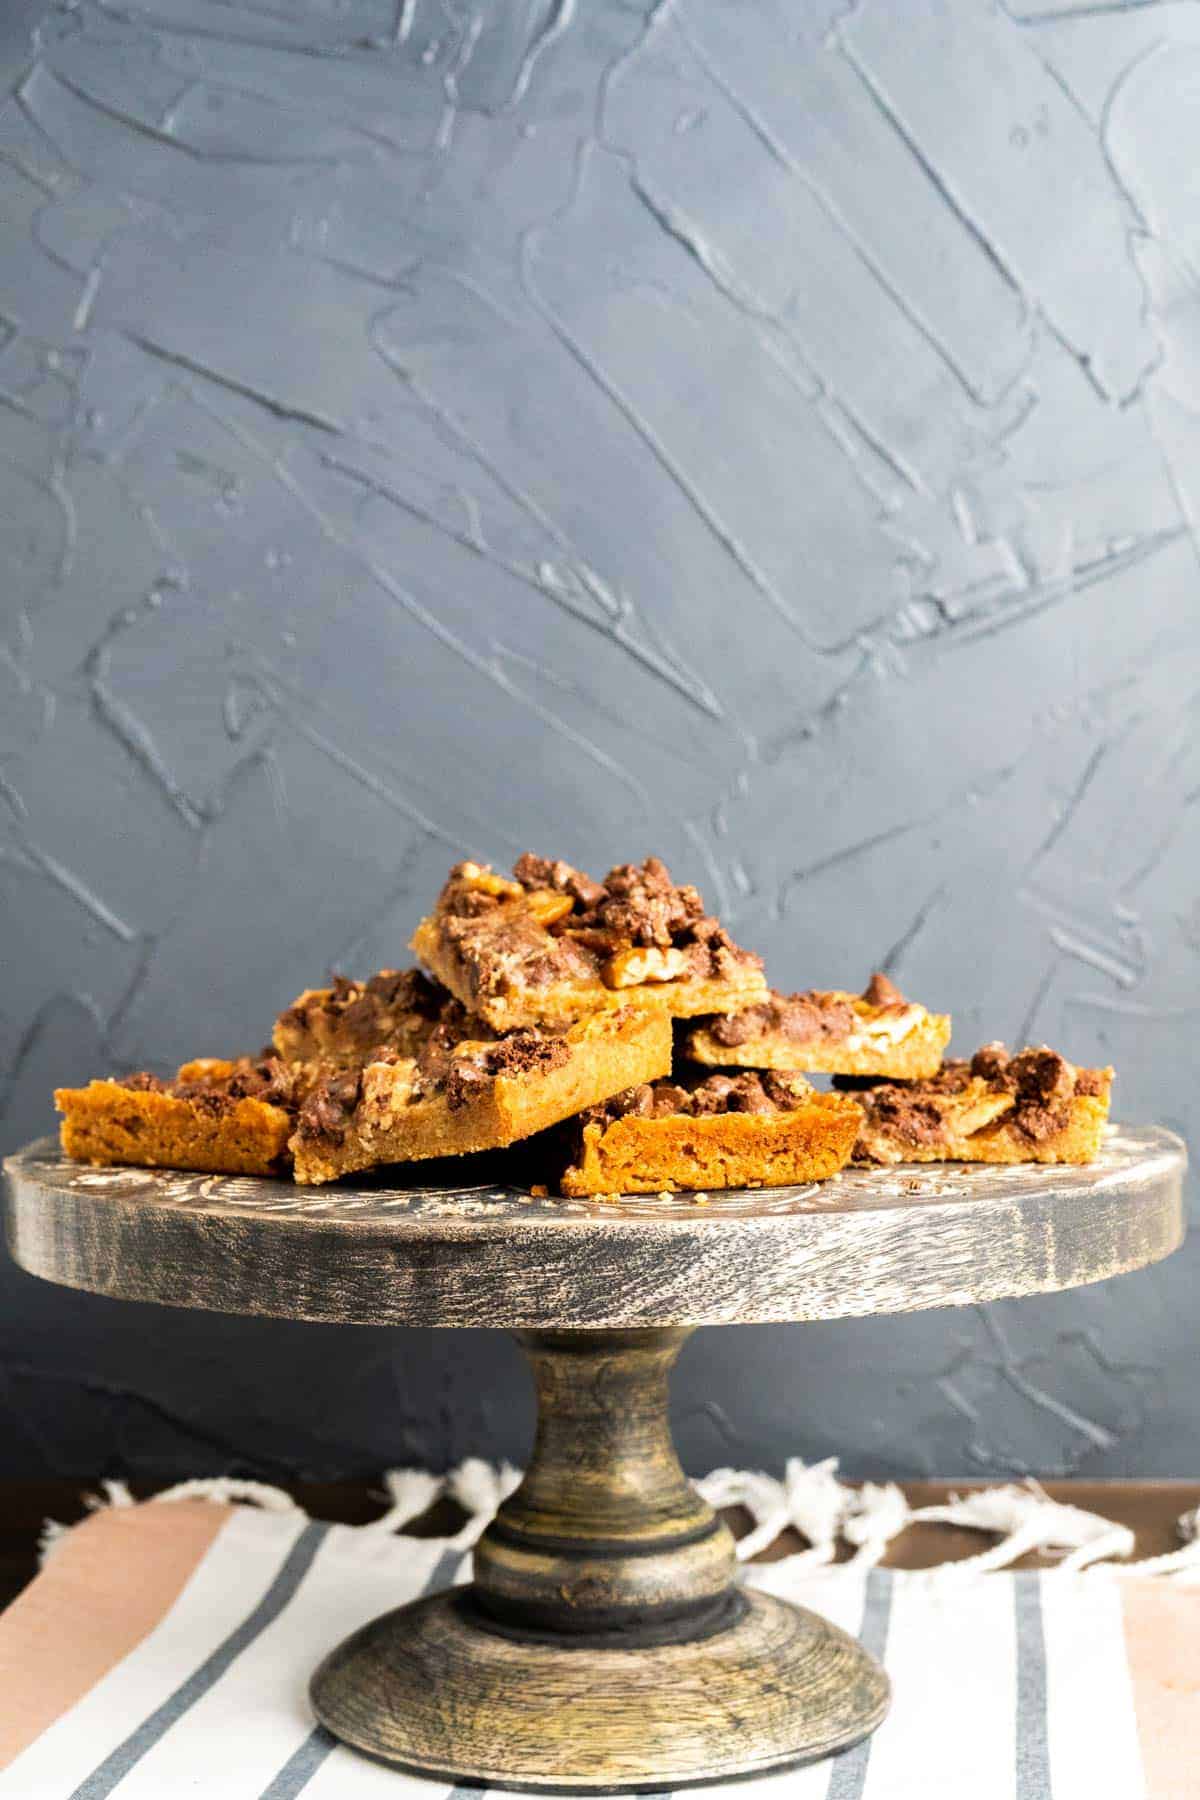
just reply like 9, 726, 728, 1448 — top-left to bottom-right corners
561, 1069, 862, 1195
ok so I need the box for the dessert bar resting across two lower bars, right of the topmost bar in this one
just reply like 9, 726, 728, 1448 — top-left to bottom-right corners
685, 974, 950, 1080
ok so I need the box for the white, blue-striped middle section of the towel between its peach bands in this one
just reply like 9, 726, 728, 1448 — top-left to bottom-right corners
0, 1507, 1165, 1800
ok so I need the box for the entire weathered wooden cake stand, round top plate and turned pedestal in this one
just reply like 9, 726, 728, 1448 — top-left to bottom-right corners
5, 1130, 1186, 1793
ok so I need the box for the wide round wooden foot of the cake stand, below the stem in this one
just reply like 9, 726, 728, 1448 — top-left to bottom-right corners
311, 1589, 887, 1793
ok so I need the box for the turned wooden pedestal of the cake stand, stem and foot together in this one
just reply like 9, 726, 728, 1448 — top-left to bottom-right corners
311, 1327, 889, 1793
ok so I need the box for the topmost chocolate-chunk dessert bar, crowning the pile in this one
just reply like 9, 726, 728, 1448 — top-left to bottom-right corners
412, 855, 766, 1031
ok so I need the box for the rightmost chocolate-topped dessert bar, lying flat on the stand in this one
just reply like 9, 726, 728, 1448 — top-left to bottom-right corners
837, 1044, 1112, 1163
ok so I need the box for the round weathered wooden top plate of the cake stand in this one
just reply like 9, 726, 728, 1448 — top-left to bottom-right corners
4, 1127, 1187, 1328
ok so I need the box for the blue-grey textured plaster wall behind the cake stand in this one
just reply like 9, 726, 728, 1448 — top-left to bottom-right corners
0, 0, 1200, 1476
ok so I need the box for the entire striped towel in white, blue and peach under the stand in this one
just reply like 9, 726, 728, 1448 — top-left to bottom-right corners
0, 1499, 1200, 1800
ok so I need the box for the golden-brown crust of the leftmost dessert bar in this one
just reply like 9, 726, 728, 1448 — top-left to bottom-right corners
54, 1058, 293, 1175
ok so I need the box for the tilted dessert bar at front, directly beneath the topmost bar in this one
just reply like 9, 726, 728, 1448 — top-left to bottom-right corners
291, 1006, 671, 1183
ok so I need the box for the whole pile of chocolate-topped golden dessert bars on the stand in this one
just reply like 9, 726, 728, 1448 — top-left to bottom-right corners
56, 855, 1112, 1195
